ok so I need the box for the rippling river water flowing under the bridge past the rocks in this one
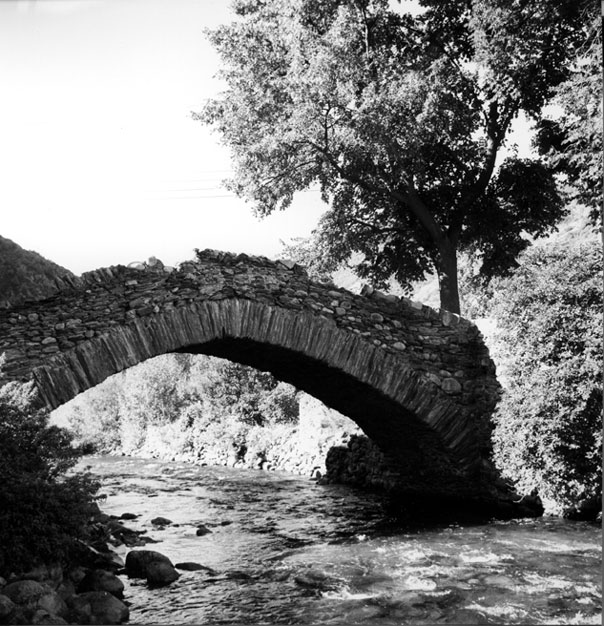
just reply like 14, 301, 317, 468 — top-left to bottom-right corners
86, 457, 602, 626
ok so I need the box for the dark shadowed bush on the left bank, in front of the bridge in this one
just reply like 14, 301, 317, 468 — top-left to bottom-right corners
0, 370, 98, 576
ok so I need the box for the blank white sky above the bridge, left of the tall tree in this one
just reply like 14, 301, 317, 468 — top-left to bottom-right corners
0, 0, 532, 274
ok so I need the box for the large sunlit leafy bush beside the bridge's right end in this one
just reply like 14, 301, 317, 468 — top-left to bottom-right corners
487, 228, 603, 514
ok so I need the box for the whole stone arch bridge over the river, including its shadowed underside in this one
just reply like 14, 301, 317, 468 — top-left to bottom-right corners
0, 250, 499, 502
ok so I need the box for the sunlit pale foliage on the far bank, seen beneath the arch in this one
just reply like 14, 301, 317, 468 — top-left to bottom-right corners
61, 354, 298, 454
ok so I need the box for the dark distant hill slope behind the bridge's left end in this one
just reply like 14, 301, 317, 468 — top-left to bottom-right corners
0, 237, 73, 308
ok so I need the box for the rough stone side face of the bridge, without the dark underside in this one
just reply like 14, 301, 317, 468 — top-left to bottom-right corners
0, 250, 499, 488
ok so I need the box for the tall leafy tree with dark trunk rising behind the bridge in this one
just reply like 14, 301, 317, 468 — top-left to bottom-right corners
196, 0, 584, 312
